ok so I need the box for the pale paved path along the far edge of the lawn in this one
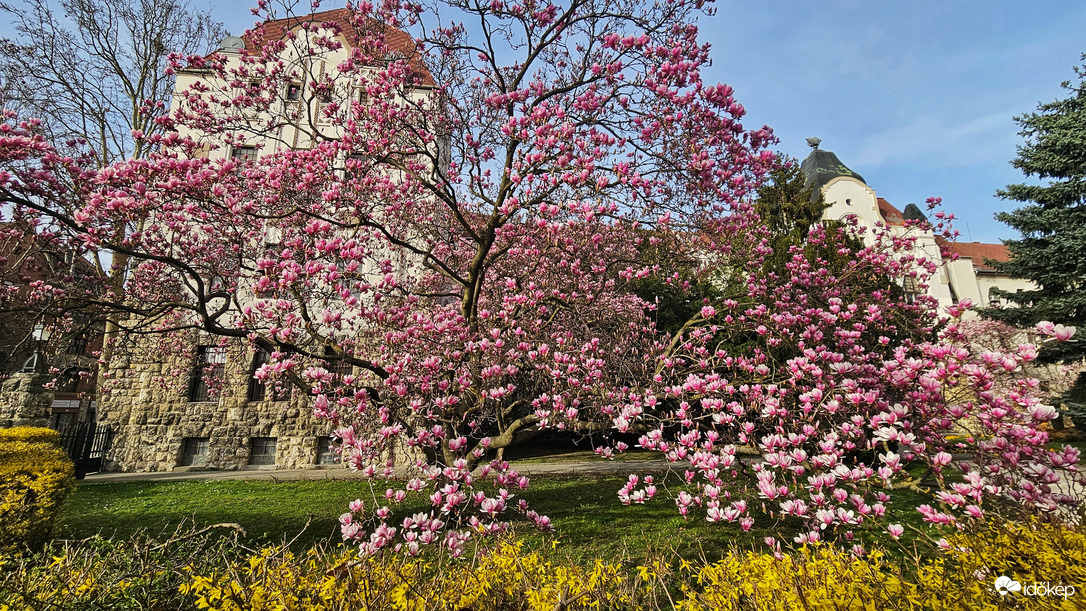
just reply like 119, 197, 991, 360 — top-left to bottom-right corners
84, 459, 668, 483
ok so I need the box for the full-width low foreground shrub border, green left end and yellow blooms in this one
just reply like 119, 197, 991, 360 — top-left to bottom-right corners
0, 521, 1086, 611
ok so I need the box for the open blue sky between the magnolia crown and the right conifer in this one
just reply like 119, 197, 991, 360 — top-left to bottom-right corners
205, 0, 1086, 242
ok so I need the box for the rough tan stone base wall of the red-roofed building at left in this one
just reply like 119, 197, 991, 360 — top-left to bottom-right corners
98, 341, 343, 472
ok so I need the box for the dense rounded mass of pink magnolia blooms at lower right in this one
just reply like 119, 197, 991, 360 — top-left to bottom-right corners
614, 213, 1083, 553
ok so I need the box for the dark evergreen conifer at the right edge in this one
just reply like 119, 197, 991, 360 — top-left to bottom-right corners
984, 54, 1086, 421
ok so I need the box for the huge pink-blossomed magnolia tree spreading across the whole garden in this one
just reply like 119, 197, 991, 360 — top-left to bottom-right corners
0, 1, 1077, 553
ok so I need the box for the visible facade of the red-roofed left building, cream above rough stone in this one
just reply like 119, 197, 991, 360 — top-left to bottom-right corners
99, 9, 432, 471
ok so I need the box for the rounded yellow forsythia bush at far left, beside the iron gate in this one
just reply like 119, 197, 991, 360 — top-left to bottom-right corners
0, 427, 75, 553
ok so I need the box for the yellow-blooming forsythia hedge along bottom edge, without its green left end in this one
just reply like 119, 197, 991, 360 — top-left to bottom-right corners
181, 522, 1086, 611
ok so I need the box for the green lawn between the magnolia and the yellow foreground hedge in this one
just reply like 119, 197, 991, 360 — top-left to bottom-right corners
55, 475, 933, 560
